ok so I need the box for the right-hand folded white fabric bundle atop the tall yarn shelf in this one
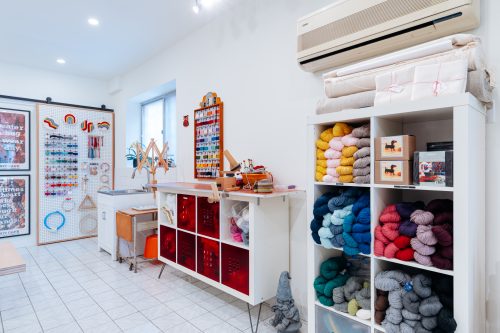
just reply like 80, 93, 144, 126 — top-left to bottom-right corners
412, 60, 467, 101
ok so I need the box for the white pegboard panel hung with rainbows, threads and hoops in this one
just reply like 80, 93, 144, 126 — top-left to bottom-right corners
37, 104, 114, 244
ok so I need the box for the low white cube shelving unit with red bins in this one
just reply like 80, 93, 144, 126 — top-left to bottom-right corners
157, 183, 289, 305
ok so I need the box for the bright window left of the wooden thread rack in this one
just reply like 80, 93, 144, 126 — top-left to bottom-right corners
141, 91, 177, 166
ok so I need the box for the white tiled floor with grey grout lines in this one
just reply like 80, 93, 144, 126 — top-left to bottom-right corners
0, 239, 307, 333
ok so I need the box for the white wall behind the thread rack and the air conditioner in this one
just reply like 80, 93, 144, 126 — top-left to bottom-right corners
113, 0, 500, 326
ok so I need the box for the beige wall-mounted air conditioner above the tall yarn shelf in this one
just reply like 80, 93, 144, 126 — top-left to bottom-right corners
298, 0, 480, 72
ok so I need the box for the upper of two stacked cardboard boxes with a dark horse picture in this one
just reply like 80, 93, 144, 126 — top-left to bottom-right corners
375, 135, 416, 161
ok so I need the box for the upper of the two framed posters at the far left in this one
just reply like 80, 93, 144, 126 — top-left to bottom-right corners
0, 108, 30, 171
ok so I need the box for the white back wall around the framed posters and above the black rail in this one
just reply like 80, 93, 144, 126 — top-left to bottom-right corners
0, 63, 110, 246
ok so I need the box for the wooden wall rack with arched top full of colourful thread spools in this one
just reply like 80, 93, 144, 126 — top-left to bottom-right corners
193, 92, 224, 180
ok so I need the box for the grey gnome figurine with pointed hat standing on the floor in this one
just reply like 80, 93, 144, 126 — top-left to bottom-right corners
270, 272, 302, 333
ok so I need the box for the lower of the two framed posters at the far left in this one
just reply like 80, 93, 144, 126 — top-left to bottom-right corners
0, 175, 30, 238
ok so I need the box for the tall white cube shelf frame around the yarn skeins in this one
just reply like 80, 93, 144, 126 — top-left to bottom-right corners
307, 93, 486, 333
